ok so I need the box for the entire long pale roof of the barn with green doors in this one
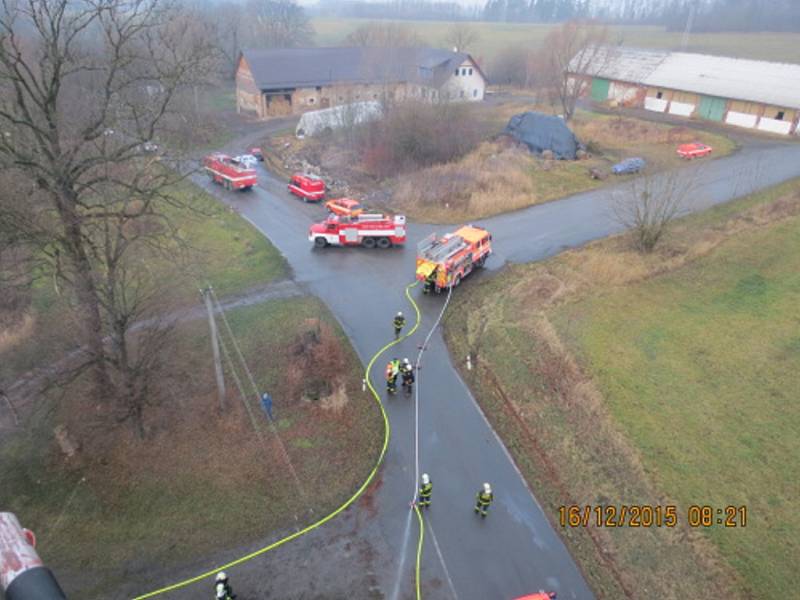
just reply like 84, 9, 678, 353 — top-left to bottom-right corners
570, 47, 800, 108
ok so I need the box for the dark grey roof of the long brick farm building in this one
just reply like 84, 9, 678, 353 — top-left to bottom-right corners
242, 47, 483, 90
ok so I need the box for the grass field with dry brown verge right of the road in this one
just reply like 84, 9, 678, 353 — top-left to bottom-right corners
446, 181, 800, 598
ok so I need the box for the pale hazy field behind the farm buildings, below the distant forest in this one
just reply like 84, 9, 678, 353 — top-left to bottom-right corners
312, 18, 800, 64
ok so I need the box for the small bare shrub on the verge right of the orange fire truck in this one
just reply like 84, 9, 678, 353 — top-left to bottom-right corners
612, 171, 697, 252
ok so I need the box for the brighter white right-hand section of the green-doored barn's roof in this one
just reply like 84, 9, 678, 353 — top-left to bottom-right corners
643, 52, 800, 108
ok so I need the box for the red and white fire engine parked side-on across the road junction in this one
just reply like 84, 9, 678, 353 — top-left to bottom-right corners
308, 213, 406, 248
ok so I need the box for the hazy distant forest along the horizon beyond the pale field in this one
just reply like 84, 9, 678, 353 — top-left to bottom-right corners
311, 0, 800, 32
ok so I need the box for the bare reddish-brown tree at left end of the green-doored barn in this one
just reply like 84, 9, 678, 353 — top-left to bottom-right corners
542, 21, 613, 121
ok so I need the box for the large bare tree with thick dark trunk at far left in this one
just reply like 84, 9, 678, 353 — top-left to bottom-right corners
0, 0, 214, 433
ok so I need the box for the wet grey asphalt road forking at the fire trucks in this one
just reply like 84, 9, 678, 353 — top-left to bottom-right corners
189, 136, 800, 600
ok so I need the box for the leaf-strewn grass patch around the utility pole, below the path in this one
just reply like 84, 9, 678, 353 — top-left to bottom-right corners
0, 297, 381, 598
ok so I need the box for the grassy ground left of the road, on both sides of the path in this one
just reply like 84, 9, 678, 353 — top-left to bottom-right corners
0, 177, 382, 598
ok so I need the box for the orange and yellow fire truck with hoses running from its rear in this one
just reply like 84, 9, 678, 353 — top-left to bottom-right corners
417, 225, 492, 294
